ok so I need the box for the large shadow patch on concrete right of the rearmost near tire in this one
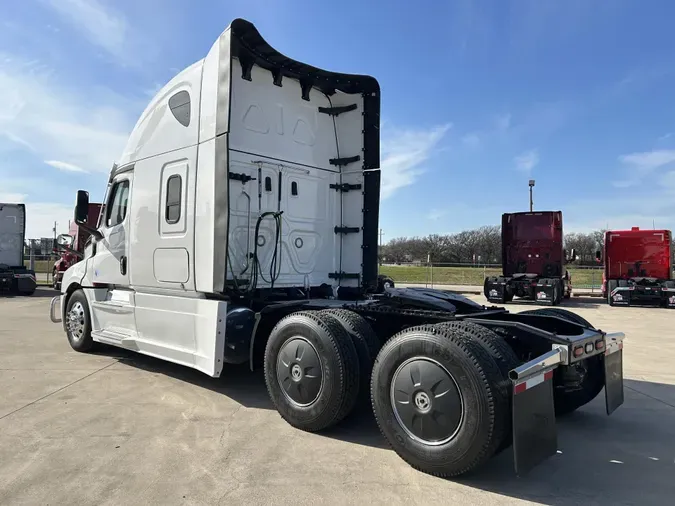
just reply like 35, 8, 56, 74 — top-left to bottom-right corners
454, 380, 675, 506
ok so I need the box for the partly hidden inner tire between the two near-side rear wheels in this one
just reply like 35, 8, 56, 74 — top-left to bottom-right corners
319, 309, 380, 402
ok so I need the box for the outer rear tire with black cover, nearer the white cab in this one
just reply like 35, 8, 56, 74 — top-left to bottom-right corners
264, 311, 360, 432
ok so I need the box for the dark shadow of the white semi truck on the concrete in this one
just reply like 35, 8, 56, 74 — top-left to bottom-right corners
99, 348, 675, 506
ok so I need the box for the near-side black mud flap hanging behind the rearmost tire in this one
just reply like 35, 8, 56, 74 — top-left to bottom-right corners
513, 370, 558, 476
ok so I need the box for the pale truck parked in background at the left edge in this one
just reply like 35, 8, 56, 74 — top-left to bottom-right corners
0, 202, 37, 295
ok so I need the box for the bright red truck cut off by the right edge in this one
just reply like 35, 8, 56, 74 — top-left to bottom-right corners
596, 227, 675, 308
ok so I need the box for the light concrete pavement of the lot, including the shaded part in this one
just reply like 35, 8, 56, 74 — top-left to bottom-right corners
0, 289, 675, 505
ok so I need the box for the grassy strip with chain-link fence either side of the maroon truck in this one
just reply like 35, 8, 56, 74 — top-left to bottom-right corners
380, 262, 603, 293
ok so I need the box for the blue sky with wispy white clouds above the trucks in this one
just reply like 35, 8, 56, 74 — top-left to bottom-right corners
0, 0, 675, 241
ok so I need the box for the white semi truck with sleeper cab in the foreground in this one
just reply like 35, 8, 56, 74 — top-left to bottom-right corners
50, 19, 624, 476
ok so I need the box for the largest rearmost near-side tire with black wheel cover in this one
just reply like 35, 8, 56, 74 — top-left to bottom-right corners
371, 325, 507, 476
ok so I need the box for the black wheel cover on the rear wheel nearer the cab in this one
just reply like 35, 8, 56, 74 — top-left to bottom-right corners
277, 337, 323, 406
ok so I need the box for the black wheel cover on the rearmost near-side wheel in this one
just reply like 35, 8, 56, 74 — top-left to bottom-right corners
390, 357, 464, 445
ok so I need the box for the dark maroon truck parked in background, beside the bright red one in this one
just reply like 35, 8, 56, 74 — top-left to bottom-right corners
483, 211, 574, 306
